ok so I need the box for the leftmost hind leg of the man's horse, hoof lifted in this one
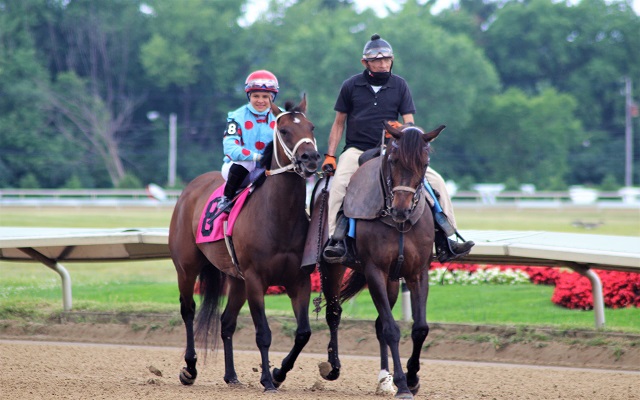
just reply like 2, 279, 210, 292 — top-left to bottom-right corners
320, 262, 345, 381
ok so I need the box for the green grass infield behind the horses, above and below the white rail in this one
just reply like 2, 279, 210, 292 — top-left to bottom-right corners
0, 208, 640, 333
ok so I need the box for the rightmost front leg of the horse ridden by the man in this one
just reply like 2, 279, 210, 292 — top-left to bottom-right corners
407, 268, 429, 395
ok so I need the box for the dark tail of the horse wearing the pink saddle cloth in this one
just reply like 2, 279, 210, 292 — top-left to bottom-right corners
195, 264, 226, 357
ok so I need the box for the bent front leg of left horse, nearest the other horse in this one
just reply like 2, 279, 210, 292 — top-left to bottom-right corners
272, 274, 311, 387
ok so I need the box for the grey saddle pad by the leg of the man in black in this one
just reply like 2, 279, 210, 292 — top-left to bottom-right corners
343, 157, 384, 219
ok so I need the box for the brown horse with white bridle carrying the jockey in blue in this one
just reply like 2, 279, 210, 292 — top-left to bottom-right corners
169, 96, 320, 391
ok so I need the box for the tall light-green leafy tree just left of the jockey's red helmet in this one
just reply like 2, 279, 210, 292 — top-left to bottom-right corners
140, 0, 248, 180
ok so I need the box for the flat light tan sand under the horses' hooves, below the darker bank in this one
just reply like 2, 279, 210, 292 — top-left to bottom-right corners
0, 341, 640, 400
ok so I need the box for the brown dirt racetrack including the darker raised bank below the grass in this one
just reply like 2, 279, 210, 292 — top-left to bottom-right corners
0, 321, 640, 400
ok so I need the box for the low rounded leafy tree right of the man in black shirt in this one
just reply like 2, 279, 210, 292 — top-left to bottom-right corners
469, 89, 582, 190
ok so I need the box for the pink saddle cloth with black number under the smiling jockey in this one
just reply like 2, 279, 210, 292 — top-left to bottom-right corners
196, 185, 250, 243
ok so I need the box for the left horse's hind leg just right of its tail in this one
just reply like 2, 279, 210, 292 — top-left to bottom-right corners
220, 278, 247, 386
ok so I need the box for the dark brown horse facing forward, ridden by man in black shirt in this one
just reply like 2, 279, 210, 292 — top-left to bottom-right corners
320, 123, 444, 398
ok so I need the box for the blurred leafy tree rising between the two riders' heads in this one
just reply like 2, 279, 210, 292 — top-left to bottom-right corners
248, 0, 378, 152
